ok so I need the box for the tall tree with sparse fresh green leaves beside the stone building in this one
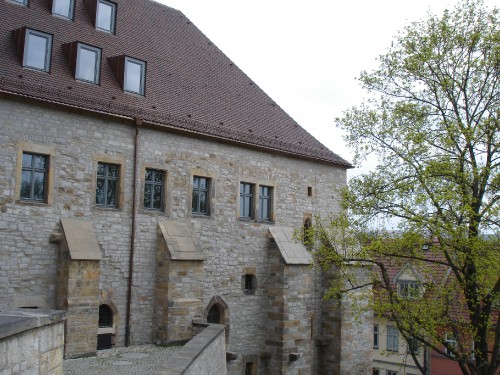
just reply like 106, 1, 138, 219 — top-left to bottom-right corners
310, 0, 500, 375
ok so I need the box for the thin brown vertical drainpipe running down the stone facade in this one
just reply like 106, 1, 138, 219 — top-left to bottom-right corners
125, 118, 142, 346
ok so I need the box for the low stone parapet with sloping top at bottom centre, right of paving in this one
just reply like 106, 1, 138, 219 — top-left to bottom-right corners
156, 324, 227, 375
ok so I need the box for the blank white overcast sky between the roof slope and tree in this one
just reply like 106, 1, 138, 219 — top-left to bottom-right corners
155, 0, 500, 174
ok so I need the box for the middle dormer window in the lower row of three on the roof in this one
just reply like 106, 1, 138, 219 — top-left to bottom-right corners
62, 42, 101, 85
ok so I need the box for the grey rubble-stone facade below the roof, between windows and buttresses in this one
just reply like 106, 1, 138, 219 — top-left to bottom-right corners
0, 98, 376, 374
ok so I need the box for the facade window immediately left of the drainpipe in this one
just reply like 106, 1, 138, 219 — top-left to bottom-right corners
95, 163, 120, 208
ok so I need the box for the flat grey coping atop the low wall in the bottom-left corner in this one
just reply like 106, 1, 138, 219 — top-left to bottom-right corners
0, 308, 67, 339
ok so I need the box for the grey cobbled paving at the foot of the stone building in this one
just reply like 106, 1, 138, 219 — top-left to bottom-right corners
64, 345, 181, 375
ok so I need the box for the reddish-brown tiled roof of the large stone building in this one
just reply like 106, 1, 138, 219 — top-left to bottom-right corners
0, 0, 351, 168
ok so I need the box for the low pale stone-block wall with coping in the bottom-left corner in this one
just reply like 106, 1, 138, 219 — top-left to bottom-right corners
0, 309, 66, 375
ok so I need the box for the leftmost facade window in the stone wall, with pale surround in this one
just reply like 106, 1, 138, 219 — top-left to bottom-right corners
20, 152, 49, 202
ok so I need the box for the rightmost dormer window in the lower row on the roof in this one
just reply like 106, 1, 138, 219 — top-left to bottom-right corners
108, 55, 146, 96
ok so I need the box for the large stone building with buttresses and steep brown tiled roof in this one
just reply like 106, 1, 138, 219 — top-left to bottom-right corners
0, 0, 372, 374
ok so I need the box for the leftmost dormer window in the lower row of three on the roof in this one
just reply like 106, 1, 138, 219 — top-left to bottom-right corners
13, 27, 52, 72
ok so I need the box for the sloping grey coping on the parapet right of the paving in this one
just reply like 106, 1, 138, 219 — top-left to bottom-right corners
155, 324, 226, 375
